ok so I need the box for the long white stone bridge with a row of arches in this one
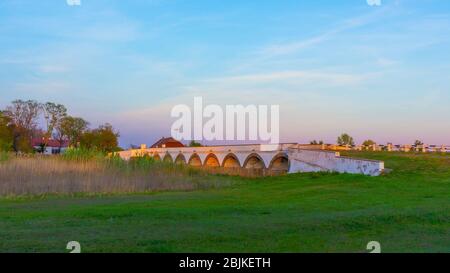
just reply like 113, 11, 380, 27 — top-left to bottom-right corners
117, 143, 384, 176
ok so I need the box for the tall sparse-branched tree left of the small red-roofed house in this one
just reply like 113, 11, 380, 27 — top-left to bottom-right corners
4, 100, 41, 153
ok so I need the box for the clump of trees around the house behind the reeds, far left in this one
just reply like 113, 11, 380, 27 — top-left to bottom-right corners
0, 100, 120, 153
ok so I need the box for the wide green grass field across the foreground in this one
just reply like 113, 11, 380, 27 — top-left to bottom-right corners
0, 152, 450, 252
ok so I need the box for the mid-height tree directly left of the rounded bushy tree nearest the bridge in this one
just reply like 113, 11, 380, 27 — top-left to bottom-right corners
55, 116, 89, 146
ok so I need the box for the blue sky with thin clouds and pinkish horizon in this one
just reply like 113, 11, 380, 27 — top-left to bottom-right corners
0, 0, 450, 147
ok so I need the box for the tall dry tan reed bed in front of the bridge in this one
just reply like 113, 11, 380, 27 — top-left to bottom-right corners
0, 156, 231, 196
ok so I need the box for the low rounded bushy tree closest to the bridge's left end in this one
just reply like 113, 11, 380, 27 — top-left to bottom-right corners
80, 123, 120, 153
